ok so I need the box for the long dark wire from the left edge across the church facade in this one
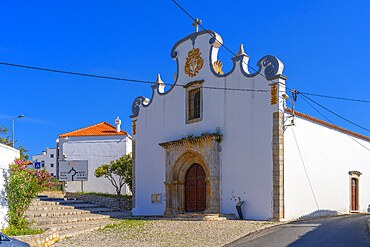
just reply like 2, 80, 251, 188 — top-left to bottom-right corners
0, 62, 270, 93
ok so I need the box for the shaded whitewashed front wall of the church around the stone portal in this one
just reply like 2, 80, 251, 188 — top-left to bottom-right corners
133, 33, 284, 219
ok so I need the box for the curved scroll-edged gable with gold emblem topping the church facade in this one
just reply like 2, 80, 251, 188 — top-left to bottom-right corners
130, 30, 286, 118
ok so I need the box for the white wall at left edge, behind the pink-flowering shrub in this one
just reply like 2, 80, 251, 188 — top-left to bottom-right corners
0, 143, 20, 225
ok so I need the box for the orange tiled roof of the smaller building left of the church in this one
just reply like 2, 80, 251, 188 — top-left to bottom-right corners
59, 122, 127, 138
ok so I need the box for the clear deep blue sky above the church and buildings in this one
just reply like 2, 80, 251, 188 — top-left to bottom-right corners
0, 0, 370, 155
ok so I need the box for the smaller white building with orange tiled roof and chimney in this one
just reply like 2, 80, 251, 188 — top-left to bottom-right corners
57, 119, 132, 194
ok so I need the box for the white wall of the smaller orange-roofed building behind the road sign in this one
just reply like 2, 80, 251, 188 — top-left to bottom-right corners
59, 135, 131, 194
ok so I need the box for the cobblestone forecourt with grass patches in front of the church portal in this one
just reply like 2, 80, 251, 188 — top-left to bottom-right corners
55, 219, 275, 247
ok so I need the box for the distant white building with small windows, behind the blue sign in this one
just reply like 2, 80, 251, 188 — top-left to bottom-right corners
32, 148, 57, 177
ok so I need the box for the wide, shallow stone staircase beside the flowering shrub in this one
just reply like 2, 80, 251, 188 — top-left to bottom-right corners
26, 196, 131, 239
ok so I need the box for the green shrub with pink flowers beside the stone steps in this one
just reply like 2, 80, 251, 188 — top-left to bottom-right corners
5, 159, 57, 229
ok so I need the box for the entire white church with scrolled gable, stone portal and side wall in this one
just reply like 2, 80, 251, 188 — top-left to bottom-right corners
131, 31, 370, 220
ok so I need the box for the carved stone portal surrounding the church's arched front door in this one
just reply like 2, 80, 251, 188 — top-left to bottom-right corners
159, 134, 221, 215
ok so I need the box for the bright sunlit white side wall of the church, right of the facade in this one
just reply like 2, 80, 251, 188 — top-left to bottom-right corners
284, 117, 370, 219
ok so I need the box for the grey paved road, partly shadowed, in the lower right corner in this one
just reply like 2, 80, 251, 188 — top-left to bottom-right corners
227, 214, 370, 247
